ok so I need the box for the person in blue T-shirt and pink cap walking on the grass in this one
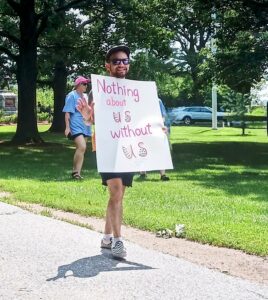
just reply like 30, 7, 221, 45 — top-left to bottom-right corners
63, 76, 91, 180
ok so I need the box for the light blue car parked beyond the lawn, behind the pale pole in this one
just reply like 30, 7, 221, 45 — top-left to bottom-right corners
168, 106, 224, 125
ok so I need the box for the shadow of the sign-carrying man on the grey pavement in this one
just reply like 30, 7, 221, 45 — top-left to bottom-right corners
47, 250, 154, 281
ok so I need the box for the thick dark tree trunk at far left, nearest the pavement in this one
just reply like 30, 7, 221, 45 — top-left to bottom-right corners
12, 1, 43, 144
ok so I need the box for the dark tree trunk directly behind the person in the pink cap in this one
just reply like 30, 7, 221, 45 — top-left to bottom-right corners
49, 61, 67, 132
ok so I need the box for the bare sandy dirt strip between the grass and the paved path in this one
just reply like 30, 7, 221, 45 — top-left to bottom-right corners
16, 202, 268, 284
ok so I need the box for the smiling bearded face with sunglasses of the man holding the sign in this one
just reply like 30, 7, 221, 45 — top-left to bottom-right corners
105, 51, 129, 78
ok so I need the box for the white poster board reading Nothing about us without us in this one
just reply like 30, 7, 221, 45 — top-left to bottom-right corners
91, 74, 173, 172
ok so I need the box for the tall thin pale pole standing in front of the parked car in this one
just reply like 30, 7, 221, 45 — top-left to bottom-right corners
211, 8, 218, 130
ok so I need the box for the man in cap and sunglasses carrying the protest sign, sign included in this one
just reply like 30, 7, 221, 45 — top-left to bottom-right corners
77, 46, 173, 258
